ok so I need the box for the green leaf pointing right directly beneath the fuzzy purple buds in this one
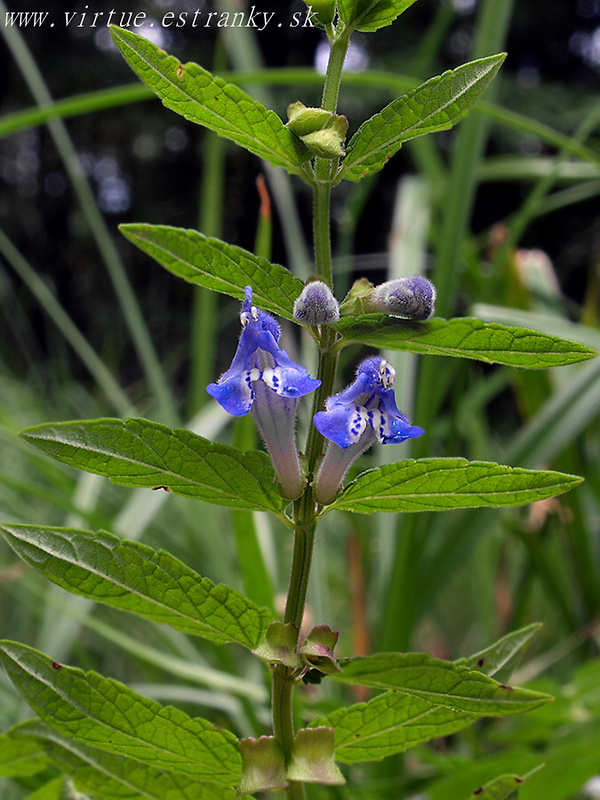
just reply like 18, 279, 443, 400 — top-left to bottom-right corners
332, 314, 597, 369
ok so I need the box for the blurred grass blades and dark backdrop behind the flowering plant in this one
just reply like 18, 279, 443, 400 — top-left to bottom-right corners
0, 0, 600, 800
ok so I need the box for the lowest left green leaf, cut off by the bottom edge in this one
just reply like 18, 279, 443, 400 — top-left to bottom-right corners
21, 721, 250, 800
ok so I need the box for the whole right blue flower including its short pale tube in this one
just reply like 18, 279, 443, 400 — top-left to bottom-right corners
314, 357, 425, 505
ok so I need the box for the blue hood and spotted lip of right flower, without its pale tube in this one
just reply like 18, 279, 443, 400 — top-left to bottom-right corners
314, 357, 425, 450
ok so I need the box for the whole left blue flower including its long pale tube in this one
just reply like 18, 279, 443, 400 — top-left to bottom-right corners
206, 286, 321, 500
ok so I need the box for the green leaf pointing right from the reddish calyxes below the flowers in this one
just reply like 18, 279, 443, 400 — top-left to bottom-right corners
329, 653, 552, 716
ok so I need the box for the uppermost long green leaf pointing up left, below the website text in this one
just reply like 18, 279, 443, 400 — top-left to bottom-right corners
111, 27, 311, 174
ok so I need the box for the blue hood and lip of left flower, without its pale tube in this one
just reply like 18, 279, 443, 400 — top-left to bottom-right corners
211, 286, 321, 417
